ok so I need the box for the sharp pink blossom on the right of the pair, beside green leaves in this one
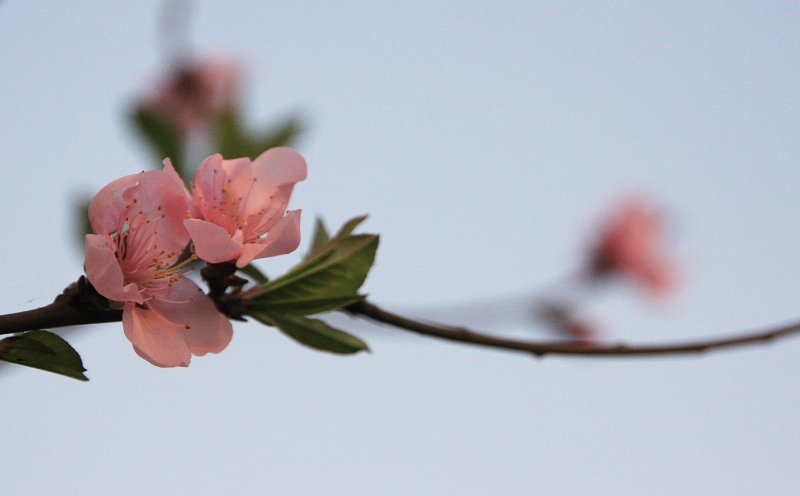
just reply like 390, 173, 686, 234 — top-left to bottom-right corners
184, 147, 306, 268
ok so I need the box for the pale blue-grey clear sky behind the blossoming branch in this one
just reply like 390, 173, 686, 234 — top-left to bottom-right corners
0, 0, 800, 496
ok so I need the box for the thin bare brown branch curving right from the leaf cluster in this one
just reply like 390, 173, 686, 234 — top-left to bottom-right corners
344, 301, 800, 357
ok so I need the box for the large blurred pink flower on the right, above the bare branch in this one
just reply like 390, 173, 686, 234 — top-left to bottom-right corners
591, 201, 677, 296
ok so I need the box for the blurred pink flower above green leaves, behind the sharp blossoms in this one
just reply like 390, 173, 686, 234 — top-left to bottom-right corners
147, 62, 239, 135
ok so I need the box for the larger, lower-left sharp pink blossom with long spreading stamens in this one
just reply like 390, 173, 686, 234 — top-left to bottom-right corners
85, 164, 233, 367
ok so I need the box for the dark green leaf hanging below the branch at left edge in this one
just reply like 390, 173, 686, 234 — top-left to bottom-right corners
0, 331, 89, 381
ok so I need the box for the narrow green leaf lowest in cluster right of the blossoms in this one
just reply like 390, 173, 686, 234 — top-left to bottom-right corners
250, 312, 369, 354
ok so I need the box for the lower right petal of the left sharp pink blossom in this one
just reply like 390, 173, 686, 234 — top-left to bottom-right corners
147, 277, 233, 356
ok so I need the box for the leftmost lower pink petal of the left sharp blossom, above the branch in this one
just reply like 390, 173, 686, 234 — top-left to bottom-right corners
84, 234, 144, 303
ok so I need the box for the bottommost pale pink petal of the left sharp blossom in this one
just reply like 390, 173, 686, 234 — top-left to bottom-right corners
122, 303, 192, 367
